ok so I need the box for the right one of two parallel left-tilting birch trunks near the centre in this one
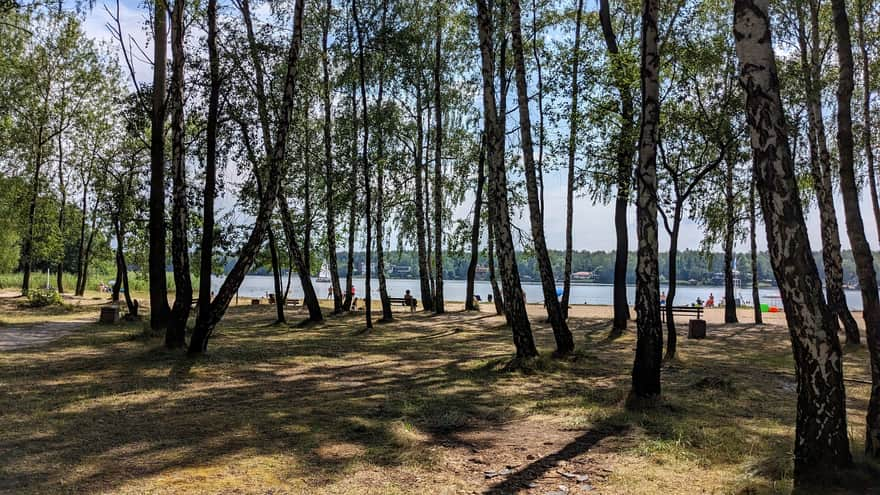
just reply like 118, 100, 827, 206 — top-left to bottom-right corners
510, 0, 574, 356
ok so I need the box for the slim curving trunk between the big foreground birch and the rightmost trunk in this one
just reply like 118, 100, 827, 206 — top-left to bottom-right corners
797, 2, 860, 344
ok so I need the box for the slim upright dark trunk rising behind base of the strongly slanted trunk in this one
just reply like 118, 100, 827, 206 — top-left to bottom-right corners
197, 0, 220, 328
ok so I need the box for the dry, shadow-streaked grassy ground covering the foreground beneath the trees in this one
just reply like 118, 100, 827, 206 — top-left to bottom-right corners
0, 298, 880, 494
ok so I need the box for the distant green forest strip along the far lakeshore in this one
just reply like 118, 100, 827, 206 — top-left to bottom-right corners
244, 250, 880, 286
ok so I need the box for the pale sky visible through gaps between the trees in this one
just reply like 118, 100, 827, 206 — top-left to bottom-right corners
77, 0, 880, 251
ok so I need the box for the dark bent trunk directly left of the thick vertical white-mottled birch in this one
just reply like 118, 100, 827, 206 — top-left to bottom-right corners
599, 0, 635, 335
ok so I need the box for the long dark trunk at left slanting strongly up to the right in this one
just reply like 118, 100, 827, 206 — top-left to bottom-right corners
189, 0, 304, 353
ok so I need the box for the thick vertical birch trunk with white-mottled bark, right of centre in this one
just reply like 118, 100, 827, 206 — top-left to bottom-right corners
632, 0, 663, 399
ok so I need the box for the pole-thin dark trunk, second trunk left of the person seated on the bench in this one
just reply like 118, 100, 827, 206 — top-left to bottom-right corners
351, 0, 373, 329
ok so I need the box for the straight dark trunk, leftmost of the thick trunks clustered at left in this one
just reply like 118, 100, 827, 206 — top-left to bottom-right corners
148, 0, 171, 330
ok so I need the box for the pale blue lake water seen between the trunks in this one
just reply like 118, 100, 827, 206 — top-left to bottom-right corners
212, 274, 862, 311
